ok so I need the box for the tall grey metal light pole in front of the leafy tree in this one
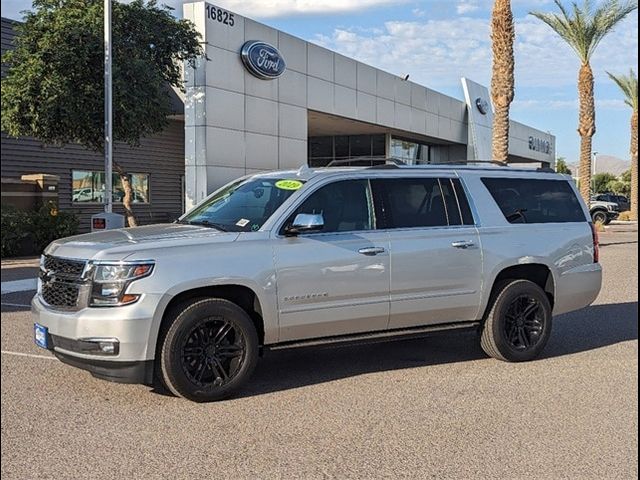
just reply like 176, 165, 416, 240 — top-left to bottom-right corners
104, 0, 113, 213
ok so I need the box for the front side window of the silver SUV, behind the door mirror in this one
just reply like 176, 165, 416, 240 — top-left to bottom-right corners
285, 180, 375, 233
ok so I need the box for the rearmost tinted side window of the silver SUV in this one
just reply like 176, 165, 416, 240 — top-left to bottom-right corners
482, 178, 586, 223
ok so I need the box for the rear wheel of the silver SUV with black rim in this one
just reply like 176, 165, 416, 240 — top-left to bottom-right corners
480, 280, 552, 362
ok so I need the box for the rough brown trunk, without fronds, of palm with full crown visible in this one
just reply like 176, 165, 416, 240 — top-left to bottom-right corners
578, 63, 596, 204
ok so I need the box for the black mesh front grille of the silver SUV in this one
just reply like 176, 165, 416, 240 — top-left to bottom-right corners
40, 255, 86, 309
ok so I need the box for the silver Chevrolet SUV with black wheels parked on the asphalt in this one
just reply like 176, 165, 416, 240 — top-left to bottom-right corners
32, 165, 602, 401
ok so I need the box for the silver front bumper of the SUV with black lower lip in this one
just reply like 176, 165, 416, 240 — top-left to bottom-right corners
31, 294, 160, 383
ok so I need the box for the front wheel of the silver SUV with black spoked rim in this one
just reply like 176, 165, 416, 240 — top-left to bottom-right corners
157, 298, 258, 402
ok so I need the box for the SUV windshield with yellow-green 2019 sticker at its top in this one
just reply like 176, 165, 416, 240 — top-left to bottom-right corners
180, 177, 304, 232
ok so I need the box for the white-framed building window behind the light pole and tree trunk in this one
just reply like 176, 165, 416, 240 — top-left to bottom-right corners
71, 170, 149, 203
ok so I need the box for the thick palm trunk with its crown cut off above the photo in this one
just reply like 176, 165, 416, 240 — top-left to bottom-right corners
491, 0, 515, 162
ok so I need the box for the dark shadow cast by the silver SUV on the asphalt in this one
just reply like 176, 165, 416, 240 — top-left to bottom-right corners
235, 302, 638, 398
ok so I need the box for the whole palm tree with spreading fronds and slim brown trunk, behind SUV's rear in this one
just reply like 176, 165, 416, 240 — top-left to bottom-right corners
531, 0, 638, 202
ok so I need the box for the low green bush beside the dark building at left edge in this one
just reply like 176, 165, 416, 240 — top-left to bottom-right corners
1, 204, 78, 258
